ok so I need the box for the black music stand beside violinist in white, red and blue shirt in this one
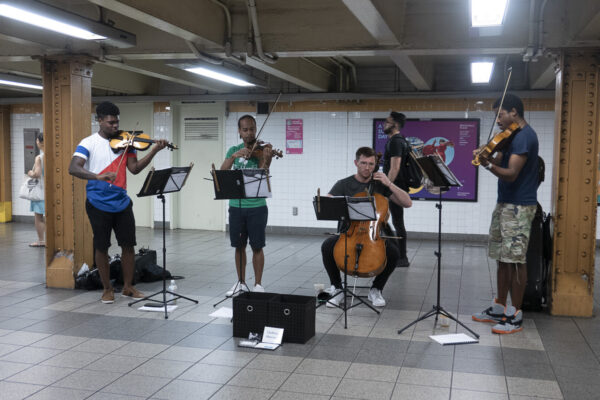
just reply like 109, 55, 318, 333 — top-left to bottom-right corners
128, 164, 198, 319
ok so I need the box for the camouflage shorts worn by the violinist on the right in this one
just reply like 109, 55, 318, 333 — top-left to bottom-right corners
488, 203, 537, 264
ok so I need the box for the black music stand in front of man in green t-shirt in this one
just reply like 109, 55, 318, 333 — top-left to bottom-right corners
211, 164, 271, 307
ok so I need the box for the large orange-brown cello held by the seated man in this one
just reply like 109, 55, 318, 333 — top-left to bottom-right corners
333, 192, 389, 278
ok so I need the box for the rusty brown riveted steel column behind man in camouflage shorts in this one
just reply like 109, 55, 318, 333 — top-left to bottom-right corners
550, 49, 600, 317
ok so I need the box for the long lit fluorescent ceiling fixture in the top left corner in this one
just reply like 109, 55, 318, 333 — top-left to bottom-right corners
0, 0, 136, 48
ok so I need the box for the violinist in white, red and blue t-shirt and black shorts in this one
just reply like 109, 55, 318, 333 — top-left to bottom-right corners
69, 102, 167, 304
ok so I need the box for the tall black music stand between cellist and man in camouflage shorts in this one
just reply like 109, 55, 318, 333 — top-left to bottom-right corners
398, 154, 479, 338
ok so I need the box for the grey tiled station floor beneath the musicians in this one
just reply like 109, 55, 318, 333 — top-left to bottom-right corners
0, 223, 600, 400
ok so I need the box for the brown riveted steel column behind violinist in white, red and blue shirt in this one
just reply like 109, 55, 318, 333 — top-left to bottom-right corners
41, 56, 93, 288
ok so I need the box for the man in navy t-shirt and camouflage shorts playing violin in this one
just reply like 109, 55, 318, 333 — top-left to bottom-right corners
472, 93, 538, 334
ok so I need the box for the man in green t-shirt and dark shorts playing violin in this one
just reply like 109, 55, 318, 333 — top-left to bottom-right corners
220, 115, 273, 296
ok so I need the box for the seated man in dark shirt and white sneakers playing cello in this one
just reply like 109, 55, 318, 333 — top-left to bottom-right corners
321, 147, 412, 307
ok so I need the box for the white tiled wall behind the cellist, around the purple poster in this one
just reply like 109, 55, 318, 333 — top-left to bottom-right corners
226, 111, 554, 234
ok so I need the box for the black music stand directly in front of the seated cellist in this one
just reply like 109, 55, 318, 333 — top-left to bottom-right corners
313, 196, 379, 329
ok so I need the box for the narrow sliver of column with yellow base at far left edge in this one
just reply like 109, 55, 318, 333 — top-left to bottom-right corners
0, 106, 12, 222
